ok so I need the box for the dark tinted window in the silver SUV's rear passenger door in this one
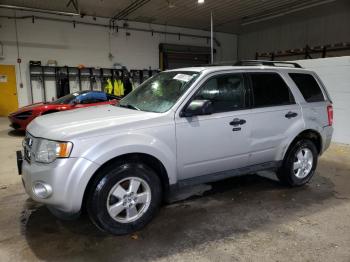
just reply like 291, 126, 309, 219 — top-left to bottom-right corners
248, 73, 295, 107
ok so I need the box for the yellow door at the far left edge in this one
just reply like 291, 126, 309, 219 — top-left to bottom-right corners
0, 65, 18, 116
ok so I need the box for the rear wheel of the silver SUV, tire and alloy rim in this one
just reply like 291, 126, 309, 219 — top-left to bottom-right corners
277, 139, 318, 187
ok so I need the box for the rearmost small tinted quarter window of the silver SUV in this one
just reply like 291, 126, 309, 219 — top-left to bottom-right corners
289, 73, 324, 102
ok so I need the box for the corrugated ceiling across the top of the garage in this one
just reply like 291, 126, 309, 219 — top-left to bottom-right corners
0, 0, 350, 33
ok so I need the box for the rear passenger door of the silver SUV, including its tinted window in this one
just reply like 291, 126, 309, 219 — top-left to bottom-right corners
247, 72, 304, 165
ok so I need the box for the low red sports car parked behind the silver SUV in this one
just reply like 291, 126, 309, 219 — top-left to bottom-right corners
8, 91, 119, 130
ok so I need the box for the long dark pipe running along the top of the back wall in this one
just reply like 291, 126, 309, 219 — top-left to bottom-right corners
0, 15, 221, 46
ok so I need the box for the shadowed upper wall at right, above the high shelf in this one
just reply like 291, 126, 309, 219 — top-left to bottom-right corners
238, 10, 350, 59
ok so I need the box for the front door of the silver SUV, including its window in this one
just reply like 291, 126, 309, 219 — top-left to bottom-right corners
176, 73, 251, 180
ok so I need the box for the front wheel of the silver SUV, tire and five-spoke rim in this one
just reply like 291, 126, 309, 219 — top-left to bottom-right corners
87, 162, 162, 235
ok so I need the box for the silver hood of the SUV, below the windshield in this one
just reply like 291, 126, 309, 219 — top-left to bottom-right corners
27, 105, 159, 140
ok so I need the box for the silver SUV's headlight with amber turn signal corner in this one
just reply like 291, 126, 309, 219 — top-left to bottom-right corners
35, 139, 73, 163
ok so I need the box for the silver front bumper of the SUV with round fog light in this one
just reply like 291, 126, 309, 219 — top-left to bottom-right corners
22, 158, 99, 214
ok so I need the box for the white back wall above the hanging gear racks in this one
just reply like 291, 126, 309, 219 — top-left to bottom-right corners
0, 10, 237, 106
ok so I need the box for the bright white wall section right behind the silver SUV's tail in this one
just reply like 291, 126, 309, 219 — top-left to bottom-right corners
296, 56, 350, 144
